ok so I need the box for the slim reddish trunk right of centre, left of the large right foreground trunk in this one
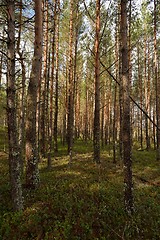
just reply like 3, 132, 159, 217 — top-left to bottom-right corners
93, 0, 100, 164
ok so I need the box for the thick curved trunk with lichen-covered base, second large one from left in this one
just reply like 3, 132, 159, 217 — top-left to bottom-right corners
26, 0, 42, 188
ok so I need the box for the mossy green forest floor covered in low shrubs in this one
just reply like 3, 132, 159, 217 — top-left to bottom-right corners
0, 142, 160, 240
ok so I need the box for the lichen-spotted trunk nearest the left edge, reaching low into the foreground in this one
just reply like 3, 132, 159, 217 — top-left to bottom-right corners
7, 0, 23, 211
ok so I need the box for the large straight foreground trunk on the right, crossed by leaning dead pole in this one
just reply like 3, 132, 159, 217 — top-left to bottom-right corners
121, 0, 133, 213
